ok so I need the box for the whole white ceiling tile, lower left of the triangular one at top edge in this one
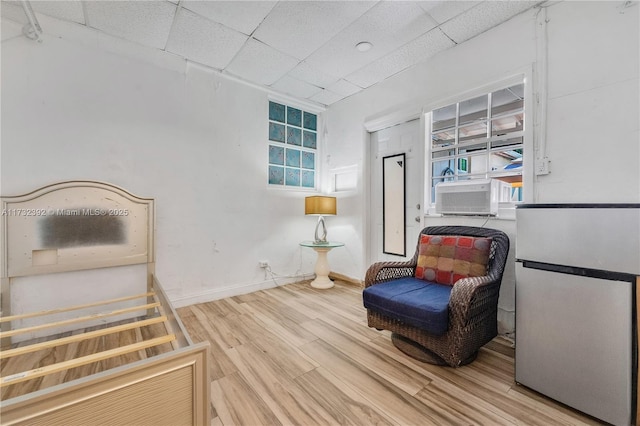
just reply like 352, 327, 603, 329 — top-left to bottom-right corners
166, 9, 249, 69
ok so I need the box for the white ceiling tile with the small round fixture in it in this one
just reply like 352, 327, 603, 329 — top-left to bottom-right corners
307, 1, 436, 77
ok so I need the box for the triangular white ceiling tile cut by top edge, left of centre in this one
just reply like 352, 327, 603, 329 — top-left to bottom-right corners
180, 0, 277, 35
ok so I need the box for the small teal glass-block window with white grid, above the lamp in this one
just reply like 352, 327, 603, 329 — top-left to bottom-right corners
269, 101, 318, 188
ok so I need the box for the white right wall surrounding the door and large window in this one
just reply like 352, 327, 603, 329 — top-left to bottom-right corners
326, 2, 640, 331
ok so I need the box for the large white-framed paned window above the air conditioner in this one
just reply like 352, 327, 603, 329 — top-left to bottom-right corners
428, 83, 525, 203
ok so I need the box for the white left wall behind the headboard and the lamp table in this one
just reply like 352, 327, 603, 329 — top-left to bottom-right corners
1, 20, 324, 306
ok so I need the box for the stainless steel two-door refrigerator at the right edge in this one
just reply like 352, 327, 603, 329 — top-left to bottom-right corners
515, 204, 640, 425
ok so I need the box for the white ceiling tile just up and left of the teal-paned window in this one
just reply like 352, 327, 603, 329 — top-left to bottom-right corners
226, 38, 298, 86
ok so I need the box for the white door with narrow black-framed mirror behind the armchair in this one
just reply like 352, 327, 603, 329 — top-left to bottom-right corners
369, 119, 424, 264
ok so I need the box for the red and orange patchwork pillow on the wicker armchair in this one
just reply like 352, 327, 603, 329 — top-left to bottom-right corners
415, 235, 491, 285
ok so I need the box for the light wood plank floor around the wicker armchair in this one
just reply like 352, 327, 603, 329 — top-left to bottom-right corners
178, 282, 599, 426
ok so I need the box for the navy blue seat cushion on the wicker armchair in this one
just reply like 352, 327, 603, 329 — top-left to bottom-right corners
362, 277, 453, 335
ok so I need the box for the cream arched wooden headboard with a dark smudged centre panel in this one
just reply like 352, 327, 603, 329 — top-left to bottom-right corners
2, 181, 154, 278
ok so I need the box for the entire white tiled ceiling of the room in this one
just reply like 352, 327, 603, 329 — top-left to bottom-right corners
1, 0, 540, 105
